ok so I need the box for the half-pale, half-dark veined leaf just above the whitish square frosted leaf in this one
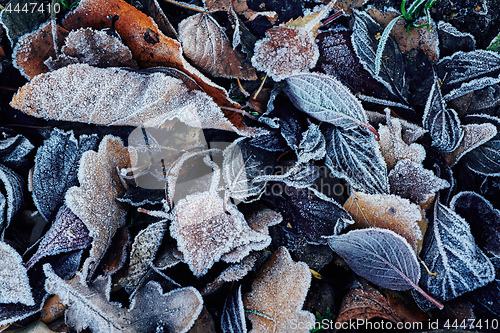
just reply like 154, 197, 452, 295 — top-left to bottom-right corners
222, 138, 274, 202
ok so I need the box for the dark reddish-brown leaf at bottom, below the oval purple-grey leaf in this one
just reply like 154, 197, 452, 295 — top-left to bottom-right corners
337, 280, 402, 323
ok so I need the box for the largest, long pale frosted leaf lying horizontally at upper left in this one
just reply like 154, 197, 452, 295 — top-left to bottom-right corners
11, 64, 247, 132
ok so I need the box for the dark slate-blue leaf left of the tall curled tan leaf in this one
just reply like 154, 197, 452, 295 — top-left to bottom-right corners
32, 128, 98, 222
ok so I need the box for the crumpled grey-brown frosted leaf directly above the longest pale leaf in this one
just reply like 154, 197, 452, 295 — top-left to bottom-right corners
45, 28, 137, 71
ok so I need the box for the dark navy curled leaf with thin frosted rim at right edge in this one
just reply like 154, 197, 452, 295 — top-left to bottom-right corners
450, 192, 500, 256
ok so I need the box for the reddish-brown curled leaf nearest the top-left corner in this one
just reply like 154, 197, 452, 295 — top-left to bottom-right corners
13, 23, 69, 79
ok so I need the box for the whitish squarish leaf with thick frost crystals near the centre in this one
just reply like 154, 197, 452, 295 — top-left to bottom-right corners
170, 192, 271, 276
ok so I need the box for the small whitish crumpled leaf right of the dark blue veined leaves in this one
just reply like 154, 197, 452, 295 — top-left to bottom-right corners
378, 118, 425, 170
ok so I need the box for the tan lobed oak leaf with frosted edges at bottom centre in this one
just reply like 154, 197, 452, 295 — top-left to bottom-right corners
243, 247, 314, 333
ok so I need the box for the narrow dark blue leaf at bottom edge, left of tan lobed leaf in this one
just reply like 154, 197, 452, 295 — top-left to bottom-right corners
221, 285, 247, 333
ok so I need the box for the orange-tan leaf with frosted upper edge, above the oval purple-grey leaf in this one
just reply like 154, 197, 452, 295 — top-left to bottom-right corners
344, 192, 425, 253
